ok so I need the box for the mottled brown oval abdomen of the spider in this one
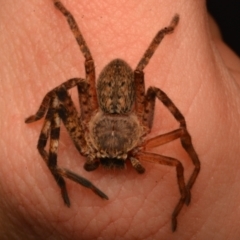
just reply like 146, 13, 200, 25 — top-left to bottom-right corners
97, 59, 135, 114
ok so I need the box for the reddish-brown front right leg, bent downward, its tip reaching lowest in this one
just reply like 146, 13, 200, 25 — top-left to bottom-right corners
134, 152, 188, 231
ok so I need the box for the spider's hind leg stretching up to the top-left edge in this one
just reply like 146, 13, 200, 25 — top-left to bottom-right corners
53, 0, 98, 122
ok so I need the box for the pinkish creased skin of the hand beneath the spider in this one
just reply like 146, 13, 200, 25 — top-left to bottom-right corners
0, 0, 240, 239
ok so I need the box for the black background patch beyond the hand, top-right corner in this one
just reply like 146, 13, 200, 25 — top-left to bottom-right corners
207, 0, 240, 57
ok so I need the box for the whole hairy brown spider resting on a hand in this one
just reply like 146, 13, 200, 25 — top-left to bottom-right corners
25, 0, 200, 231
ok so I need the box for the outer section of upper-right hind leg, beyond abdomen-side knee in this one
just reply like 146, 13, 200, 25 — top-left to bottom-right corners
136, 14, 179, 71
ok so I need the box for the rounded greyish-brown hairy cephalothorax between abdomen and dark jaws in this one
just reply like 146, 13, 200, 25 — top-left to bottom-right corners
90, 113, 142, 159
